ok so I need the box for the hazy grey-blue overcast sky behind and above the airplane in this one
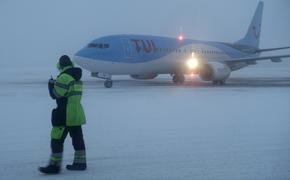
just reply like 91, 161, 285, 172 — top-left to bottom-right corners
0, 0, 290, 68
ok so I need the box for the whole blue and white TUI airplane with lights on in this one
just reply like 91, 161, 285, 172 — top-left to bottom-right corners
73, 1, 290, 88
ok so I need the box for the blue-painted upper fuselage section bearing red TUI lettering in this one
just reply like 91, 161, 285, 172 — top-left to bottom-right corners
76, 35, 246, 63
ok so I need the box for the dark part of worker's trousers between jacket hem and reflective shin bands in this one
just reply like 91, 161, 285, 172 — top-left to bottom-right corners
50, 126, 86, 153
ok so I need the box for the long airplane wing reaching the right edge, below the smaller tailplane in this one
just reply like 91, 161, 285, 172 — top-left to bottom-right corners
225, 55, 290, 63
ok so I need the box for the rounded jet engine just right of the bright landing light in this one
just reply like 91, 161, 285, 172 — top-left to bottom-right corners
199, 62, 231, 81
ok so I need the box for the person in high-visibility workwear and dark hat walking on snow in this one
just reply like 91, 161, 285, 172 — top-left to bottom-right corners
39, 55, 87, 174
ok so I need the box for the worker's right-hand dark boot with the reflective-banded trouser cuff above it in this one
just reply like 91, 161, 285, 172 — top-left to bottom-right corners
66, 150, 87, 171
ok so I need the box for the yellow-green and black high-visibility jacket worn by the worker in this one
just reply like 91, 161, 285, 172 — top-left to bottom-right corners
52, 66, 86, 126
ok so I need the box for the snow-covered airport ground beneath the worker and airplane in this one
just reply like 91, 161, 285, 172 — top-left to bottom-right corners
0, 68, 290, 180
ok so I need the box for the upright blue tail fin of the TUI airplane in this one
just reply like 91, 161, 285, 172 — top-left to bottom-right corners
236, 2, 264, 49
